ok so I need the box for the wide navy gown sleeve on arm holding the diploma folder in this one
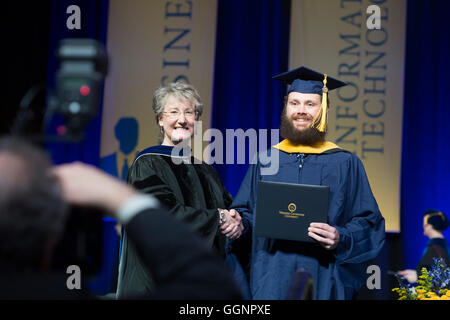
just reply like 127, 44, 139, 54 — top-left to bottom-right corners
335, 156, 385, 263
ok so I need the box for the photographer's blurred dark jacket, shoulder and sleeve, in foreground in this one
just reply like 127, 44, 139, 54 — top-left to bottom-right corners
0, 208, 241, 300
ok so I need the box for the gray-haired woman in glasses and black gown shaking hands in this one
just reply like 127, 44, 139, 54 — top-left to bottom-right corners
117, 82, 243, 299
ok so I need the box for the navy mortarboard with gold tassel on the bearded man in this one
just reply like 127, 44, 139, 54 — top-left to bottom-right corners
272, 66, 347, 132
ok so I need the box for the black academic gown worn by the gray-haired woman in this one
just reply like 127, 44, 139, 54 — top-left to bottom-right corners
117, 146, 232, 298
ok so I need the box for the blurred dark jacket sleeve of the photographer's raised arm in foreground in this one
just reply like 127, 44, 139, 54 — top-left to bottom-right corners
123, 209, 241, 300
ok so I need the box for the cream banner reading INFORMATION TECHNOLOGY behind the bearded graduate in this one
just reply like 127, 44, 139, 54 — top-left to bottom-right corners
289, 0, 406, 232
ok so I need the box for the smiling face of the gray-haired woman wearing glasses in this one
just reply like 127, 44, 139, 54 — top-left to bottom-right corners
158, 96, 196, 146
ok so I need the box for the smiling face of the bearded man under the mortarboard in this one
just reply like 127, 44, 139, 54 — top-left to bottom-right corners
286, 92, 322, 131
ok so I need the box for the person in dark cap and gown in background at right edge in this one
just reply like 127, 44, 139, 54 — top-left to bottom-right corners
397, 209, 450, 283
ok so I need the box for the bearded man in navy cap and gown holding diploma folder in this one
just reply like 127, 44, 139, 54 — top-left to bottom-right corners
231, 67, 385, 300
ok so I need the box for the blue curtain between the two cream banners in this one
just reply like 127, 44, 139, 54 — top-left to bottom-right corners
211, 0, 291, 196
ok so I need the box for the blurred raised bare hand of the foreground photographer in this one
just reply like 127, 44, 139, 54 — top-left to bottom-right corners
52, 162, 137, 215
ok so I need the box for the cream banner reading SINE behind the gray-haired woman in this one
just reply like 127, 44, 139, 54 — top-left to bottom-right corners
101, 0, 217, 177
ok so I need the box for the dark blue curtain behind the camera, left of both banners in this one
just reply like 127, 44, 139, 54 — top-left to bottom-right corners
46, 0, 118, 294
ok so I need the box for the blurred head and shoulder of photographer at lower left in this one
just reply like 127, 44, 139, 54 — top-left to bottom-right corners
0, 138, 87, 298
